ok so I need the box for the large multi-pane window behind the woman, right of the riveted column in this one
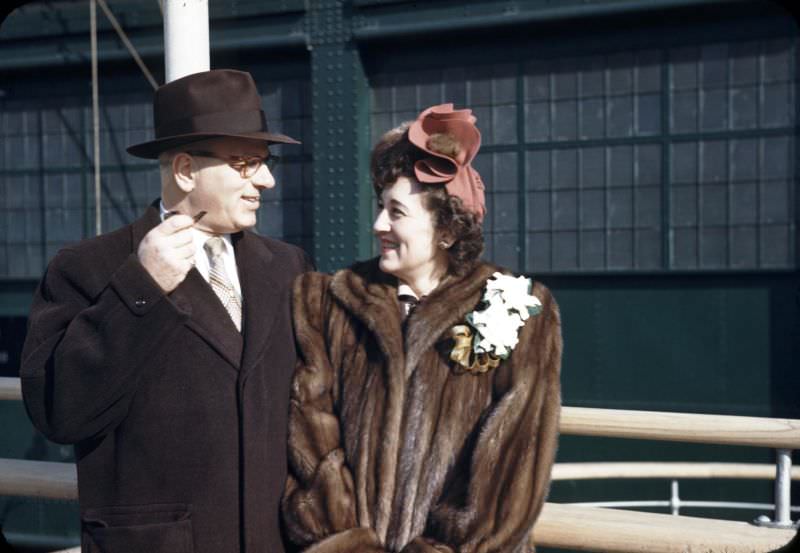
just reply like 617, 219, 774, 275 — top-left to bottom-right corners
371, 34, 797, 273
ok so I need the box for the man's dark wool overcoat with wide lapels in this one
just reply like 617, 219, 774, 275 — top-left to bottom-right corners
20, 204, 308, 553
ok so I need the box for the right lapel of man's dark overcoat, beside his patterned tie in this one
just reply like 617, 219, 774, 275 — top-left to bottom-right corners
232, 231, 282, 371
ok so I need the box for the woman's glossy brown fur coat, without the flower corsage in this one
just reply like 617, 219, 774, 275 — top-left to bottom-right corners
282, 260, 562, 553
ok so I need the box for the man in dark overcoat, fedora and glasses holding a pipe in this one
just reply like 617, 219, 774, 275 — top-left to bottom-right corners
20, 70, 309, 553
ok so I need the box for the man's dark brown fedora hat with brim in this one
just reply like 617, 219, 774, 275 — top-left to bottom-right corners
128, 69, 300, 159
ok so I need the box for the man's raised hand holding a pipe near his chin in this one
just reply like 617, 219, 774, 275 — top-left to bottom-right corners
137, 215, 194, 294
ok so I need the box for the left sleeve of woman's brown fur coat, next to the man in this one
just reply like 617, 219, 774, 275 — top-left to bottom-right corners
282, 273, 384, 553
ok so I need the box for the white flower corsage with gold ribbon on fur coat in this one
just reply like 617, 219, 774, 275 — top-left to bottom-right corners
450, 272, 542, 373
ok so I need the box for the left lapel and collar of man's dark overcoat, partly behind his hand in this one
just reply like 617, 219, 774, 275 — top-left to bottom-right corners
131, 203, 242, 370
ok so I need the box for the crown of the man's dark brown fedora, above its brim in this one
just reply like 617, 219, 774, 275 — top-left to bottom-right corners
153, 69, 261, 130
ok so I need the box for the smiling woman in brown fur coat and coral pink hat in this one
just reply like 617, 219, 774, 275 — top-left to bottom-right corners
282, 104, 561, 553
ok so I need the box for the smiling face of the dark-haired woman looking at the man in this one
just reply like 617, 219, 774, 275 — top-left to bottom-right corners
372, 177, 447, 293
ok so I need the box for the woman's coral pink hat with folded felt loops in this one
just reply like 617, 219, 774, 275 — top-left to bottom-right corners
408, 104, 486, 222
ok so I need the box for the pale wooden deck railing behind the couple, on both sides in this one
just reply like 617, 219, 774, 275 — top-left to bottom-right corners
0, 378, 800, 553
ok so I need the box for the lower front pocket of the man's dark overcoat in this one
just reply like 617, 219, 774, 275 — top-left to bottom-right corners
81, 503, 194, 553
